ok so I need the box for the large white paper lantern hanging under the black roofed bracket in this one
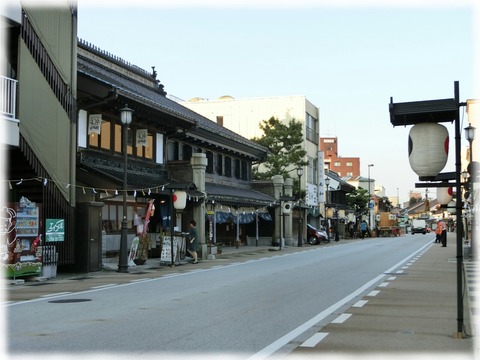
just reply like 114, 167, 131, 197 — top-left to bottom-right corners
408, 123, 449, 177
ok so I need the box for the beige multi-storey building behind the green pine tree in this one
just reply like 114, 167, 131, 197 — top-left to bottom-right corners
181, 95, 324, 224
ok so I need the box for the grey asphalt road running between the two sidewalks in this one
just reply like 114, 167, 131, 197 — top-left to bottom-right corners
4, 235, 431, 359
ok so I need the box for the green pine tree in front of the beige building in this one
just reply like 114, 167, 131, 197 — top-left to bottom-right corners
252, 116, 308, 180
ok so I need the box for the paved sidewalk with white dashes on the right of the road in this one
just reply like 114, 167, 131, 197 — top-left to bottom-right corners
292, 233, 479, 359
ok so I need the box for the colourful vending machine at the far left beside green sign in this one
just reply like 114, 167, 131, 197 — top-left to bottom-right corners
0, 197, 43, 278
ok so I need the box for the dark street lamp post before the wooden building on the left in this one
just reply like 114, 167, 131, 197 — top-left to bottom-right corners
117, 105, 133, 273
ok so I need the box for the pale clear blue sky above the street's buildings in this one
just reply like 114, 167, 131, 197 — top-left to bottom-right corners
78, 0, 480, 201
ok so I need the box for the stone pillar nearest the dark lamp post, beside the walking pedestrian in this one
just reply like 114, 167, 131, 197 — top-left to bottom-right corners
189, 153, 208, 259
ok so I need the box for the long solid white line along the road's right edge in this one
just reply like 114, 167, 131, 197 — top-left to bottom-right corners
248, 243, 431, 360
